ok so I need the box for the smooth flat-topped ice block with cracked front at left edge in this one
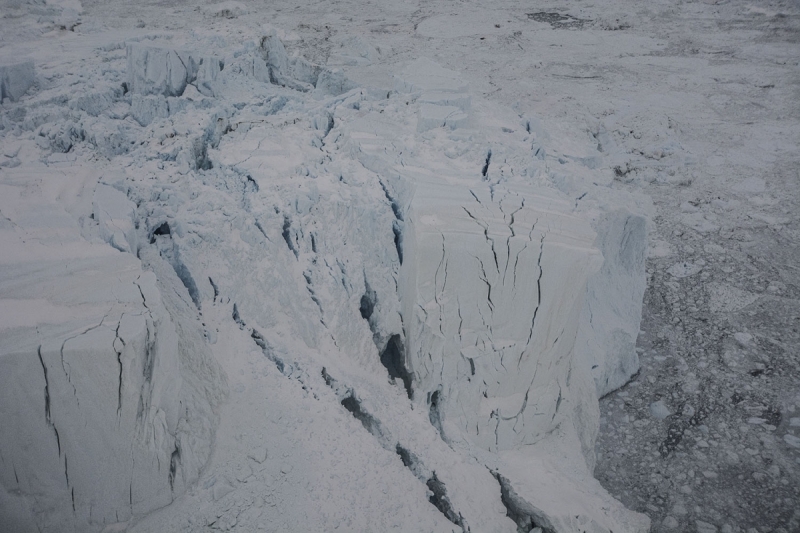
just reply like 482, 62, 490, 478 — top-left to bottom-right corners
0, 166, 223, 532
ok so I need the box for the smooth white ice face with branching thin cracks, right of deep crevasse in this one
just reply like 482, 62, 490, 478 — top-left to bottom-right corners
403, 182, 601, 451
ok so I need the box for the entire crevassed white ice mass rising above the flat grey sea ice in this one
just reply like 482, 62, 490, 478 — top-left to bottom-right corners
0, 22, 649, 533
